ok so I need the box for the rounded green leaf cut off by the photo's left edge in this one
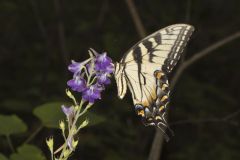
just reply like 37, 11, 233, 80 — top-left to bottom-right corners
0, 115, 27, 136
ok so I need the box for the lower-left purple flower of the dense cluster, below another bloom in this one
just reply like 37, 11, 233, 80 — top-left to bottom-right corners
67, 76, 86, 92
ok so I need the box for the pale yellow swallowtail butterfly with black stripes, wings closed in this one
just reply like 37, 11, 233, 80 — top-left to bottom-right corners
114, 24, 194, 139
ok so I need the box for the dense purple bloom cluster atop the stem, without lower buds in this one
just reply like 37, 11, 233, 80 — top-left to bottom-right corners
67, 49, 114, 103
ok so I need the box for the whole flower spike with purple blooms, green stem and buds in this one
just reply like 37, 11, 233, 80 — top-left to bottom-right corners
47, 49, 114, 160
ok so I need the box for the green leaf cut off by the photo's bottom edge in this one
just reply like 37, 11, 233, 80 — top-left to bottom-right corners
10, 144, 46, 160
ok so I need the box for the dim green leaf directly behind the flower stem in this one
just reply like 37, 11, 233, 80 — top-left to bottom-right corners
33, 102, 66, 128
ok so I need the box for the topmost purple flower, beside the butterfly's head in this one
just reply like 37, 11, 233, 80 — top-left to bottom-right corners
95, 52, 114, 73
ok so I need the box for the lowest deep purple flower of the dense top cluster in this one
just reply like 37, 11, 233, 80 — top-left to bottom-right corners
83, 84, 103, 103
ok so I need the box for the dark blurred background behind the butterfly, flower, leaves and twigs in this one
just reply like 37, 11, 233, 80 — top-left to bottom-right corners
0, 0, 240, 160
